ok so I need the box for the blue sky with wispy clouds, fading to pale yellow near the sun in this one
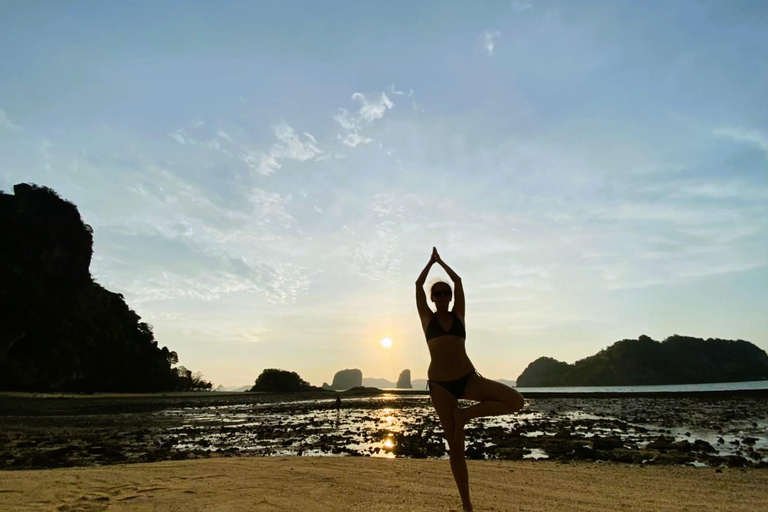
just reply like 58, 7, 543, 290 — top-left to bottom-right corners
0, 0, 768, 386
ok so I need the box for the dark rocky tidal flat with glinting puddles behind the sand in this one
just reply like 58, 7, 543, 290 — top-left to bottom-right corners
0, 393, 768, 469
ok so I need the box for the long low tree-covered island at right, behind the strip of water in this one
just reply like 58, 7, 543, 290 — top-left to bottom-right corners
517, 334, 768, 387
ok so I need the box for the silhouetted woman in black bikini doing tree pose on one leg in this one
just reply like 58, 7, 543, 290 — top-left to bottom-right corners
416, 247, 524, 512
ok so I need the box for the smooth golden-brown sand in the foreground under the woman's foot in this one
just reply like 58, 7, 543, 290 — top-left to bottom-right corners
0, 457, 768, 512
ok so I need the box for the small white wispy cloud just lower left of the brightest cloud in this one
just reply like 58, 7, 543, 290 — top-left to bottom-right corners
240, 123, 325, 176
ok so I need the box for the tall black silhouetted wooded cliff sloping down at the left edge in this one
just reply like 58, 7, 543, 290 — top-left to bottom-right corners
0, 184, 211, 392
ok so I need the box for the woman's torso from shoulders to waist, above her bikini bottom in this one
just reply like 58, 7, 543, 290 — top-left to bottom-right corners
422, 311, 475, 380
